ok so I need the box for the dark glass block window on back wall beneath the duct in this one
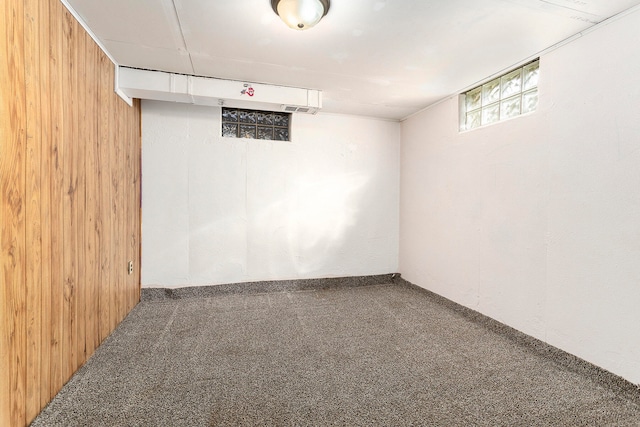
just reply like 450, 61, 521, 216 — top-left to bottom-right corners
222, 107, 291, 141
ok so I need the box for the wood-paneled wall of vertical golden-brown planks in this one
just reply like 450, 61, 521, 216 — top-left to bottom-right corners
0, 0, 141, 426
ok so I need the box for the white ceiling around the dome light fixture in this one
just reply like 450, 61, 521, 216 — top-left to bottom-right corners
68, 0, 640, 119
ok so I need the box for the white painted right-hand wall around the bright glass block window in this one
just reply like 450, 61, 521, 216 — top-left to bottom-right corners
400, 12, 640, 383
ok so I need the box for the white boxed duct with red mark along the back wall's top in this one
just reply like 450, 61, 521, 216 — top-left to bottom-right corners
116, 67, 322, 114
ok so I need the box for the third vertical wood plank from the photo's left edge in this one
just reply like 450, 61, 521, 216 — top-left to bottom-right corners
37, 1, 51, 409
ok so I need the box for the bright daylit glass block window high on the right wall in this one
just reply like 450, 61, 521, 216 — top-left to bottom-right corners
460, 59, 540, 130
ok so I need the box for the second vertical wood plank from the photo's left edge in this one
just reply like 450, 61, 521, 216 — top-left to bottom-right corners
24, 1, 42, 423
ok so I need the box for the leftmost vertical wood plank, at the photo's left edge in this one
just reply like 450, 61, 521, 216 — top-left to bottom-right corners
0, 0, 26, 425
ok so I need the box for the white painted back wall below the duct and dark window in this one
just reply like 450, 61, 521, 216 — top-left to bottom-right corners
142, 101, 400, 287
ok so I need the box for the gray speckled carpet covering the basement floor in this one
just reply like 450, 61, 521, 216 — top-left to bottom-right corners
32, 279, 640, 427
